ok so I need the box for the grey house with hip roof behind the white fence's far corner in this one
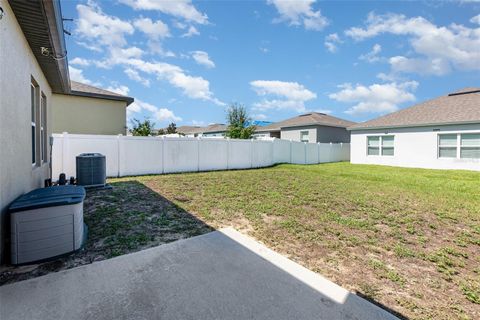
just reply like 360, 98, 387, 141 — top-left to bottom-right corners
255, 112, 355, 143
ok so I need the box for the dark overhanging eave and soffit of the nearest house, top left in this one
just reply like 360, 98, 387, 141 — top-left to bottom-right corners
9, 0, 70, 93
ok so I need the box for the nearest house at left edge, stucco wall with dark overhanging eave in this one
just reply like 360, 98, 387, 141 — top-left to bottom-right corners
0, 0, 128, 263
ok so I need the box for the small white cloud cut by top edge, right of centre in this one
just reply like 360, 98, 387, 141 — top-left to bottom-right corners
267, 0, 328, 31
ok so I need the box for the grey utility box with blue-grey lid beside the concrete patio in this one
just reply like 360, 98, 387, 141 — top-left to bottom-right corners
9, 185, 85, 264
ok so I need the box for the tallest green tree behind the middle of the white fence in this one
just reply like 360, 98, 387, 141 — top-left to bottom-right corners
226, 103, 256, 139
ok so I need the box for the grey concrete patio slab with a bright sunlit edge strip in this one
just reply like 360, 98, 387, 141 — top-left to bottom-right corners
0, 228, 397, 320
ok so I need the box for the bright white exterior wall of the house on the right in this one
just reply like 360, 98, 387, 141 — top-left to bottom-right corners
350, 123, 480, 171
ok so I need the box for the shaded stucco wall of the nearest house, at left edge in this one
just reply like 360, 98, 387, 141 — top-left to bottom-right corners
0, 0, 52, 262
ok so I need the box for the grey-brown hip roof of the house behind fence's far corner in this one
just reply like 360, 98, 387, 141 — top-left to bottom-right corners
256, 112, 355, 132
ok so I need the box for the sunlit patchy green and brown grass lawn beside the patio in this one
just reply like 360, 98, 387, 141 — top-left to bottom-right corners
108, 163, 480, 319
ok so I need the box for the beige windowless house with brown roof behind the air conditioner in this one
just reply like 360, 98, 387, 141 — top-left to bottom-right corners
51, 81, 133, 135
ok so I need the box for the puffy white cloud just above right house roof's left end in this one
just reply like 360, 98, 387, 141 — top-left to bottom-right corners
328, 81, 418, 114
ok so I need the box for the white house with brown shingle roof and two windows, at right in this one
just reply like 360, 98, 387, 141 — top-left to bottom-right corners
349, 88, 480, 170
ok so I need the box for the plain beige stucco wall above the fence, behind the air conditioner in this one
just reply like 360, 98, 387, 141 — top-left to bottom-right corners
52, 94, 127, 134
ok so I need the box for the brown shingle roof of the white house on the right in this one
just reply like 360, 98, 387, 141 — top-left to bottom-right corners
348, 88, 480, 130
